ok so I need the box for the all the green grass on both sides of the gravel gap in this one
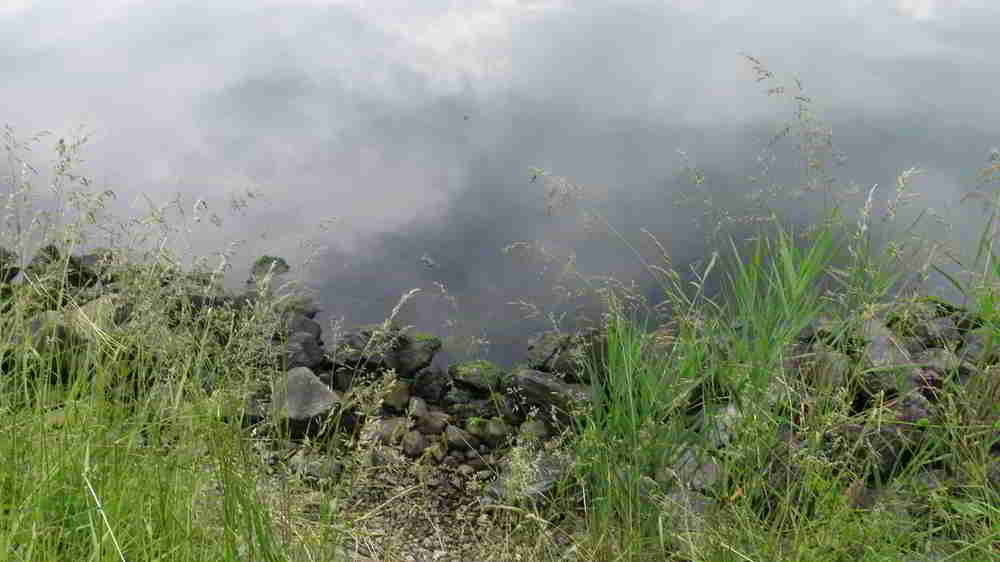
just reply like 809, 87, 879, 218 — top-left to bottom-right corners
0, 53, 1000, 562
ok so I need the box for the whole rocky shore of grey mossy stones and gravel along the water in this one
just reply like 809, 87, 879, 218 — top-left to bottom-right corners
0, 243, 1000, 560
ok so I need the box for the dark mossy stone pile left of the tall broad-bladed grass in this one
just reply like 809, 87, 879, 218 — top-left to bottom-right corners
0, 246, 589, 506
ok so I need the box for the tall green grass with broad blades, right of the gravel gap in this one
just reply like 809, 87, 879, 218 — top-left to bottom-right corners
512, 56, 1000, 560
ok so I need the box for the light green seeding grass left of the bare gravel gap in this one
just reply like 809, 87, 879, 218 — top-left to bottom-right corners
0, 127, 342, 560
